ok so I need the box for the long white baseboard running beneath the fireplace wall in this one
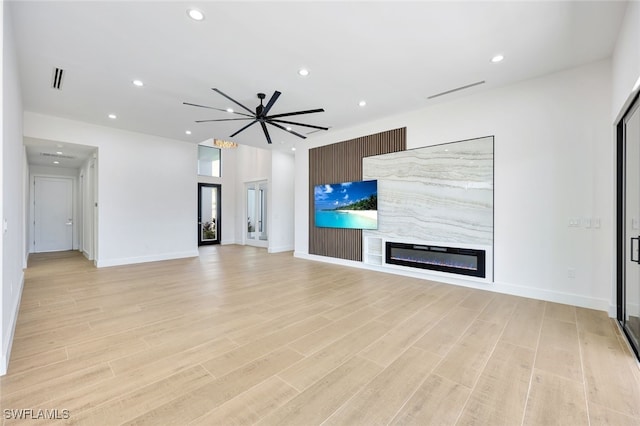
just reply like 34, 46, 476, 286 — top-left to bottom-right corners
293, 252, 616, 318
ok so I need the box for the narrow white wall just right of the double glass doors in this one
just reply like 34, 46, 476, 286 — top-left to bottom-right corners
269, 151, 295, 253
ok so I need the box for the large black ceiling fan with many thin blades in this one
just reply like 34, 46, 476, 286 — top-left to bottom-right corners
183, 89, 329, 143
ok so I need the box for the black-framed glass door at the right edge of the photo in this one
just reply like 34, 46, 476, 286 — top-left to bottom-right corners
618, 94, 640, 355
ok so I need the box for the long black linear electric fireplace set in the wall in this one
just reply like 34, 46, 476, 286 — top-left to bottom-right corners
385, 241, 486, 278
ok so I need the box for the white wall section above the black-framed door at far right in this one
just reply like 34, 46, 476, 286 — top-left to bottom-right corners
612, 1, 640, 121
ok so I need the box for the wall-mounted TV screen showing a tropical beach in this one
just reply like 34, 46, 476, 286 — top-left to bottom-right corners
314, 180, 378, 229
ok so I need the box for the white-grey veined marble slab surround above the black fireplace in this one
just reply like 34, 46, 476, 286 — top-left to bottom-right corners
362, 136, 494, 282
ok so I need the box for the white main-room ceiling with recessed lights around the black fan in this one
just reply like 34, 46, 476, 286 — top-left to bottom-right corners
5, 1, 626, 163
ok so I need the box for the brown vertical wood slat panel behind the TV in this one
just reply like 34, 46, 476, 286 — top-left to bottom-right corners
309, 127, 407, 261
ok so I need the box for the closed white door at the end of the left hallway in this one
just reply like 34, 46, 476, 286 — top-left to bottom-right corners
33, 176, 73, 253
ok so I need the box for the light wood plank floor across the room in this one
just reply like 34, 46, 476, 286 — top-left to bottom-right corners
0, 246, 640, 426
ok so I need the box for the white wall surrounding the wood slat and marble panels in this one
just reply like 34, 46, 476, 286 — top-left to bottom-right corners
295, 61, 615, 312
